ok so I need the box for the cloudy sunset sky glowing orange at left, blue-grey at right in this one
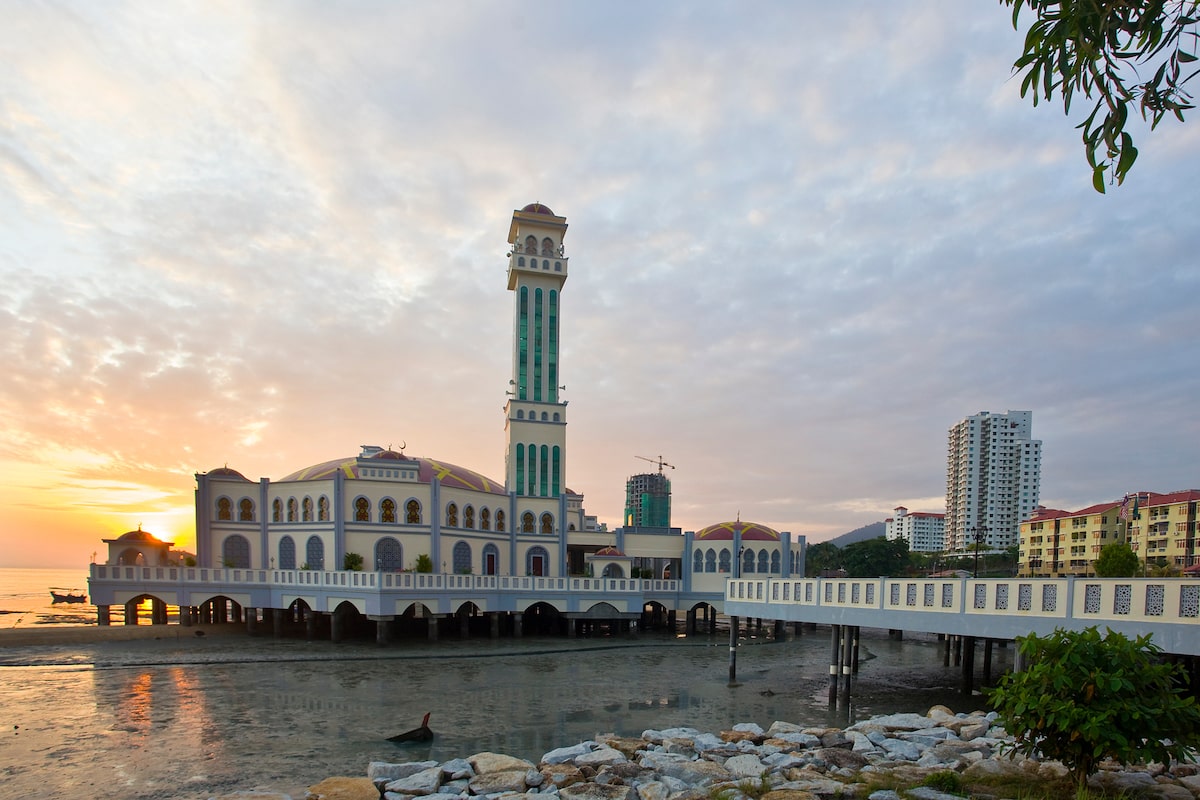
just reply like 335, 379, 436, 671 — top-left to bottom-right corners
0, 0, 1200, 566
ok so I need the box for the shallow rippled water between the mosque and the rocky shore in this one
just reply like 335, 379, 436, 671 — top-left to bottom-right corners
0, 633, 1007, 800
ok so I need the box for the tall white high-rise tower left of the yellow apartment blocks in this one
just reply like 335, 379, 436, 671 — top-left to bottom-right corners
946, 411, 1042, 551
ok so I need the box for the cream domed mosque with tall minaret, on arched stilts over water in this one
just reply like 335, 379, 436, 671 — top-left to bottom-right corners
90, 203, 804, 638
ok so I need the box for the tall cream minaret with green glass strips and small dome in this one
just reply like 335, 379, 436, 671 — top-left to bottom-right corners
504, 203, 566, 498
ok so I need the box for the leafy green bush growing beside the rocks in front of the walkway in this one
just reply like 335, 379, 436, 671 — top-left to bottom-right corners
988, 627, 1200, 787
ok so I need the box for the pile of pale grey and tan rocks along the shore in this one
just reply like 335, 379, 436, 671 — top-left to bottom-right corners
225, 706, 1200, 800
